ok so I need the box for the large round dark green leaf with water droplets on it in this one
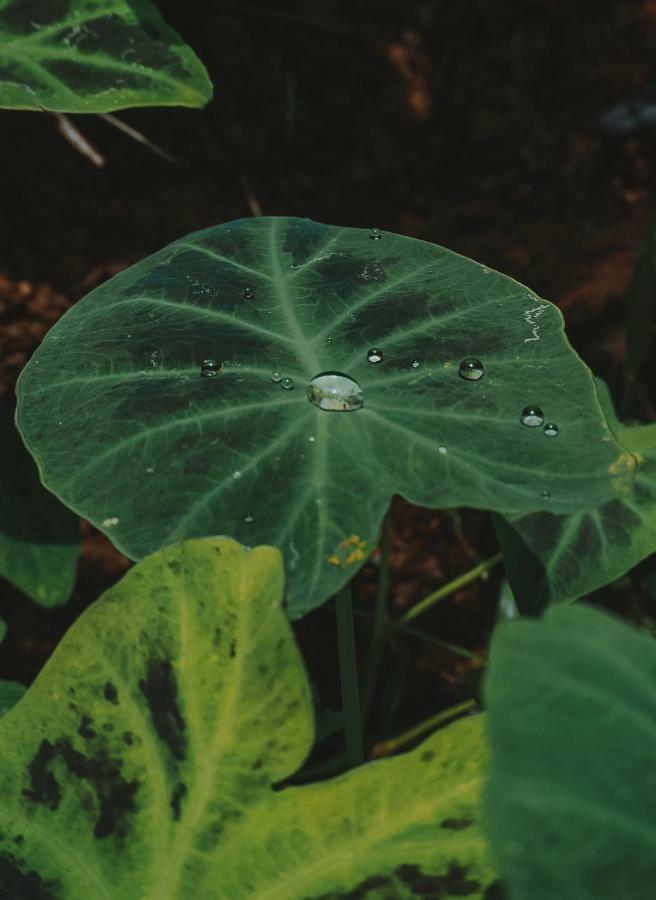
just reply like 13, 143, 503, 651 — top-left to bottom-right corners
19, 218, 633, 616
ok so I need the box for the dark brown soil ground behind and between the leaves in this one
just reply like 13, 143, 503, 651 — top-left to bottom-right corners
0, 0, 656, 760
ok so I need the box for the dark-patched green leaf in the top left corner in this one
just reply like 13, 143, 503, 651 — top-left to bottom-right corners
0, 0, 212, 113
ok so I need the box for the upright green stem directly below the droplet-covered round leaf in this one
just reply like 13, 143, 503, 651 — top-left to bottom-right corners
335, 583, 364, 769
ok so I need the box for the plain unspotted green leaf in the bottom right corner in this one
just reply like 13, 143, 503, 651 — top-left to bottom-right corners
484, 606, 656, 900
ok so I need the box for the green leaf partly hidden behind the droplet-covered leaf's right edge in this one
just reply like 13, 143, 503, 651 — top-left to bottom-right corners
493, 379, 656, 614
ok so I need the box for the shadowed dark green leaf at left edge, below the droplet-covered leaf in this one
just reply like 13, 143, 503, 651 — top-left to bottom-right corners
0, 402, 80, 606
